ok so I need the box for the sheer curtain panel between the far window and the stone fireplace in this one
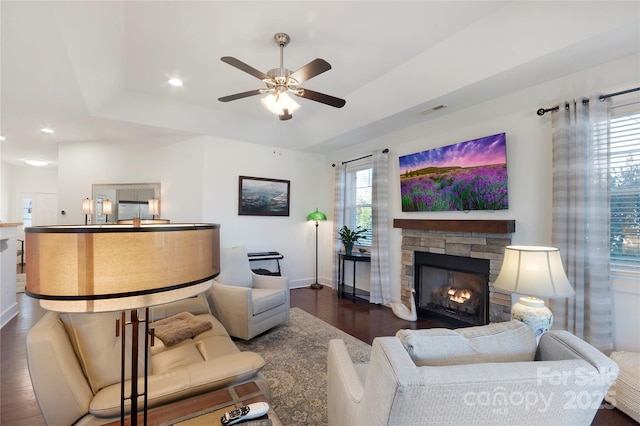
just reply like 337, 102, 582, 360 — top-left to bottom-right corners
369, 150, 391, 305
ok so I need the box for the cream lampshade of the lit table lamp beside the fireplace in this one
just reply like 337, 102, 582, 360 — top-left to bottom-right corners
493, 246, 575, 298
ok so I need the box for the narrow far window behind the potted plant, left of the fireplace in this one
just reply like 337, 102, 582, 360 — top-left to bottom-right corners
344, 162, 373, 247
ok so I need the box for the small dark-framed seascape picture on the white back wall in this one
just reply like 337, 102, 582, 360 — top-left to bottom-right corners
238, 176, 291, 216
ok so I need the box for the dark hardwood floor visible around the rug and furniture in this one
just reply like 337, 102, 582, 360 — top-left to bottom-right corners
0, 288, 638, 426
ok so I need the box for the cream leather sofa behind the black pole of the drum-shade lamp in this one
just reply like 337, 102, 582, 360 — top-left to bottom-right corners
27, 295, 270, 425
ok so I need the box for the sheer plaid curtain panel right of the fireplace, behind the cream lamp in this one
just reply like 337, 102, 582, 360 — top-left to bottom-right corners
550, 96, 613, 353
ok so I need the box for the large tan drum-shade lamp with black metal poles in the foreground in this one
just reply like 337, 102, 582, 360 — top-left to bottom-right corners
25, 224, 220, 425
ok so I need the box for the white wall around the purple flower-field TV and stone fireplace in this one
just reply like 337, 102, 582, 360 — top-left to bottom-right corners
331, 55, 640, 351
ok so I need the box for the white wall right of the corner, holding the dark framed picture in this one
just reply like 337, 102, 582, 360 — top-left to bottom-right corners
202, 137, 333, 287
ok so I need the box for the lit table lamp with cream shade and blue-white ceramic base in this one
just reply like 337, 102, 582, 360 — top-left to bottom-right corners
493, 246, 575, 341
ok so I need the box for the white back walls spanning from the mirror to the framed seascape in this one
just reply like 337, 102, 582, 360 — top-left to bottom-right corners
59, 136, 332, 287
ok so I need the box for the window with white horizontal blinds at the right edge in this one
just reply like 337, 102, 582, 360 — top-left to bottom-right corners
609, 103, 640, 273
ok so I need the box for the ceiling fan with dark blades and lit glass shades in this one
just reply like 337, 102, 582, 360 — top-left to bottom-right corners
218, 33, 346, 120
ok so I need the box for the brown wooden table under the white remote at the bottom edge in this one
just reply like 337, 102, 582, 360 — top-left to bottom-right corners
110, 382, 282, 426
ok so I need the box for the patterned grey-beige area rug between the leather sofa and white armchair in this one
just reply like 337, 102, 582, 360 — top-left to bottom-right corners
235, 308, 371, 426
